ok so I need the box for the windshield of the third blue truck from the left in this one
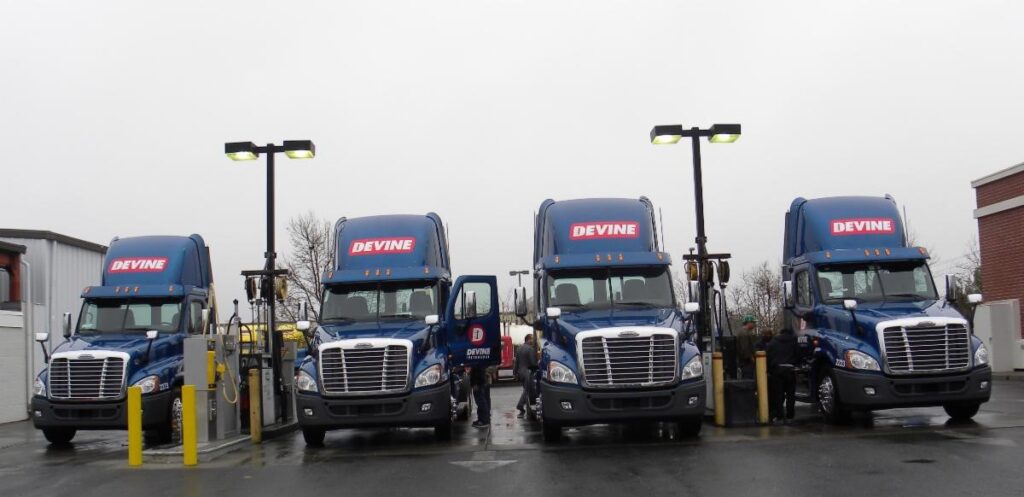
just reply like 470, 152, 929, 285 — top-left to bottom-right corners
548, 267, 674, 310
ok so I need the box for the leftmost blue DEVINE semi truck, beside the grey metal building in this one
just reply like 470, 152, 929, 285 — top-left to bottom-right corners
32, 235, 216, 444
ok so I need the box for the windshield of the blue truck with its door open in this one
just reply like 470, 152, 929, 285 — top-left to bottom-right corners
321, 281, 439, 323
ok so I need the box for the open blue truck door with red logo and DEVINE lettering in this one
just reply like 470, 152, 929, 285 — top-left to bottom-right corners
444, 276, 502, 367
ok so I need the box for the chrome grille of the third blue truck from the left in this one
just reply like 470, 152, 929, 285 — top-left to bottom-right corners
579, 332, 678, 388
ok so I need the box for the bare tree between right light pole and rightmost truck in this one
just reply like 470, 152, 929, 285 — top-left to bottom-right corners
729, 260, 782, 333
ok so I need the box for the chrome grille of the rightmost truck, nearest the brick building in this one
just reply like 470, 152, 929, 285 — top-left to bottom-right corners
882, 324, 971, 374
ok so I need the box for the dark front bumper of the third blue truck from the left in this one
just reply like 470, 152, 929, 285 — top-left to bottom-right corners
541, 379, 706, 426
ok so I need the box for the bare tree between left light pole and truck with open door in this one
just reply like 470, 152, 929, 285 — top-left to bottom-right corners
280, 211, 333, 321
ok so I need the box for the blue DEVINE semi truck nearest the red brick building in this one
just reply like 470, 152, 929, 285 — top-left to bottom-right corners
782, 196, 991, 422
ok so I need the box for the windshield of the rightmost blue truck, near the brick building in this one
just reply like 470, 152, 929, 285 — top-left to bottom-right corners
817, 260, 938, 303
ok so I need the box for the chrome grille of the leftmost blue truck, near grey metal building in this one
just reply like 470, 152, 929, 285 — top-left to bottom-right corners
49, 358, 125, 401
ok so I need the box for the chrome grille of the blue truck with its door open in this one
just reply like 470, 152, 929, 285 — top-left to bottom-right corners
319, 344, 410, 395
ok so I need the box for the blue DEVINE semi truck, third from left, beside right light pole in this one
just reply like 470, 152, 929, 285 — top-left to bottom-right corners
515, 198, 706, 442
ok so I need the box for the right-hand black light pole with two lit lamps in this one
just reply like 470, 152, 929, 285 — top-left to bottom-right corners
650, 124, 740, 348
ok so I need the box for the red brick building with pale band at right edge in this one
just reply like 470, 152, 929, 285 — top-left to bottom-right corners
971, 163, 1024, 336
